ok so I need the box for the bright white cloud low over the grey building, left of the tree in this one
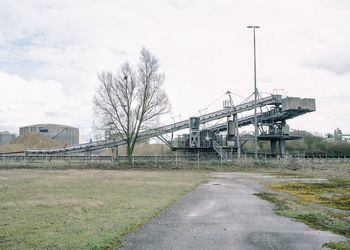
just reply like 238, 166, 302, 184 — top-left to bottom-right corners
0, 71, 92, 139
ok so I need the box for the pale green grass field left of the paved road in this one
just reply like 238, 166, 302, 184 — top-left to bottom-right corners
0, 169, 207, 249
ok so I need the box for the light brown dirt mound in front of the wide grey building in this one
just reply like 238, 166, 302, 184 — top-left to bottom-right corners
0, 133, 64, 152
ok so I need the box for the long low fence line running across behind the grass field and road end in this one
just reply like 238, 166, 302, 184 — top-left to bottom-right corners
0, 153, 350, 167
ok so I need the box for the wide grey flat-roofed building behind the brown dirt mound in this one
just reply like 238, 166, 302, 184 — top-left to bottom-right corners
19, 124, 79, 145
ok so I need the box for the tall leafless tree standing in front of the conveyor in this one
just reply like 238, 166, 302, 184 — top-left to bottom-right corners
94, 48, 170, 162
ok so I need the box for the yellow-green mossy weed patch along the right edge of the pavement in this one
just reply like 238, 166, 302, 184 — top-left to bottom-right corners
255, 178, 350, 250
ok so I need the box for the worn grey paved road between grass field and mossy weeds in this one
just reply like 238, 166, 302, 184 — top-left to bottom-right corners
117, 173, 342, 250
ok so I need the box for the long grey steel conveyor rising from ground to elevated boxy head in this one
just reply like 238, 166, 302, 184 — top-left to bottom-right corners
25, 94, 316, 159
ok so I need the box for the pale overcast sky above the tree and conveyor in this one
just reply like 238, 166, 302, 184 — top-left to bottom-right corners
0, 0, 350, 140
